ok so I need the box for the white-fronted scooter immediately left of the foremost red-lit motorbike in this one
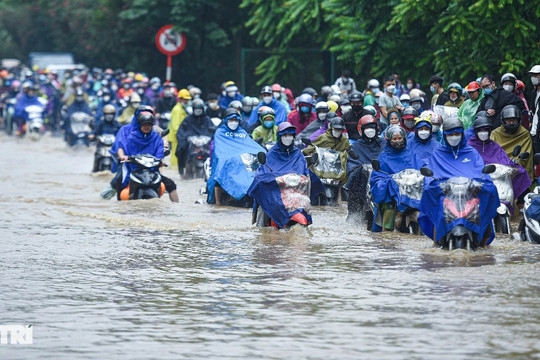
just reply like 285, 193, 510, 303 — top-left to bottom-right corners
371, 159, 424, 235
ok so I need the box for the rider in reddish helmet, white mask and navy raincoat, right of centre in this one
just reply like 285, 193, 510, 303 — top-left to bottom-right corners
346, 115, 386, 221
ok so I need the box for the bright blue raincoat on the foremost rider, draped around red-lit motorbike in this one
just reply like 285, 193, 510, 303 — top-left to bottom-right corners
418, 138, 500, 244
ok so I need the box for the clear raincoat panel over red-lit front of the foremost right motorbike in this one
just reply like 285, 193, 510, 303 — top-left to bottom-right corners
439, 177, 482, 225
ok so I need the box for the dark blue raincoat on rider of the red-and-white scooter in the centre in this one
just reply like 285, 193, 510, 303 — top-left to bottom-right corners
248, 141, 324, 228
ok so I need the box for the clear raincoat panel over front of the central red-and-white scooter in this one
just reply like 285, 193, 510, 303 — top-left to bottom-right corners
276, 174, 311, 213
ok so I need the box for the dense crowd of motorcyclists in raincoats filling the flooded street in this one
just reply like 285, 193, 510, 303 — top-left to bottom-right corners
0, 65, 540, 247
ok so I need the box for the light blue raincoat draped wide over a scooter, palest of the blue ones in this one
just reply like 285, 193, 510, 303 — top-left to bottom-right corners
207, 123, 266, 203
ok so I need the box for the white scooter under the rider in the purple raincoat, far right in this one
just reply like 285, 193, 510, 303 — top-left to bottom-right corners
491, 145, 529, 234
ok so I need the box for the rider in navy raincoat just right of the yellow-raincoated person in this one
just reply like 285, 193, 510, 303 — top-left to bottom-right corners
176, 99, 214, 177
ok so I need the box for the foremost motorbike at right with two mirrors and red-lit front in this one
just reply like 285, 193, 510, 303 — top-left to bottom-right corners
420, 164, 495, 251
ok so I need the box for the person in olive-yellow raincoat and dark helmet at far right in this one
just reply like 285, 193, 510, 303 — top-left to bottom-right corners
491, 105, 534, 180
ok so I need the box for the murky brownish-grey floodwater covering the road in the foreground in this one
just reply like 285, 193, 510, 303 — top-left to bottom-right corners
0, 134, 540, 359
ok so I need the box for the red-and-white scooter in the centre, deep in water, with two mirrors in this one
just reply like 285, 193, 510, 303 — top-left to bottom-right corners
252, 152, 318, 230
